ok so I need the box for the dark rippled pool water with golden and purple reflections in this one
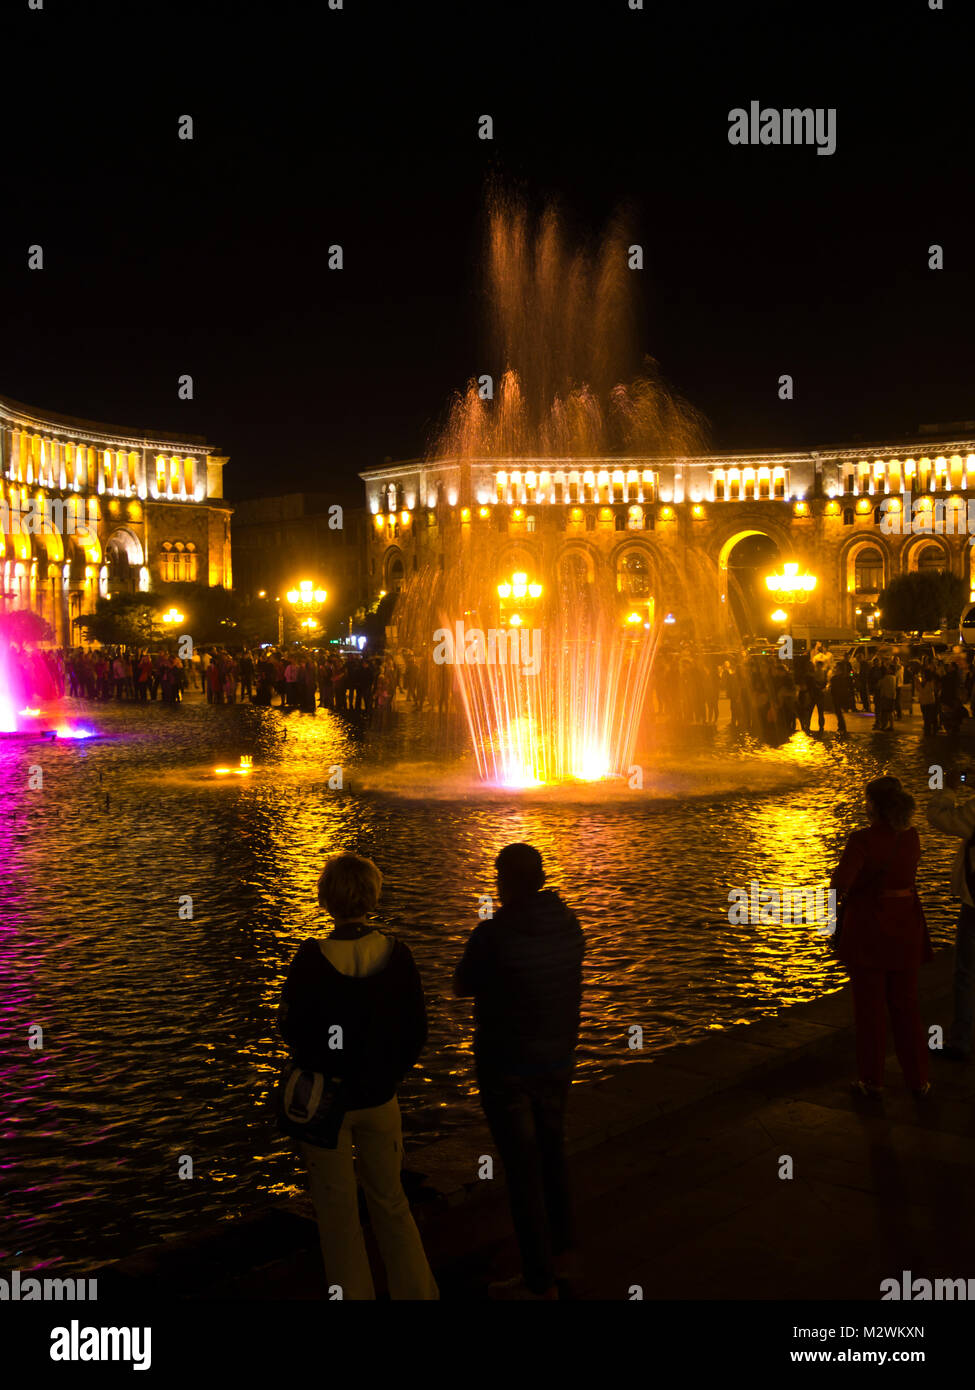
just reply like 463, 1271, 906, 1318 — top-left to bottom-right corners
0, 701, 953, 1269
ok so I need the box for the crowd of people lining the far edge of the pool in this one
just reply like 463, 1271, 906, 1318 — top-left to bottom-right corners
7, 642, 975, 738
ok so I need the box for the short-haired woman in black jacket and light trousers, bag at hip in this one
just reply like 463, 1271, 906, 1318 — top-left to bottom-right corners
278, 855, 440, 1300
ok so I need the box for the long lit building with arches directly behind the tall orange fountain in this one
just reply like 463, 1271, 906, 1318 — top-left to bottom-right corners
362, 433, 975, 641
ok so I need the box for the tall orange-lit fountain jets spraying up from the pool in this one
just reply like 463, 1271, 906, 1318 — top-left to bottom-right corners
395, 193, 701, 787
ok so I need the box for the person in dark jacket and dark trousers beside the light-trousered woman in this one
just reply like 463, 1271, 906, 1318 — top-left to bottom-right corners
453, 844, 584, 1298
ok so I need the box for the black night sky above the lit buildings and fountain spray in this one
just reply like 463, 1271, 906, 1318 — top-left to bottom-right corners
0, 0, 975, 502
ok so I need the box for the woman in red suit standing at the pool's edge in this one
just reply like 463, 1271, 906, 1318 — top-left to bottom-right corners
830, 777, 933, 1095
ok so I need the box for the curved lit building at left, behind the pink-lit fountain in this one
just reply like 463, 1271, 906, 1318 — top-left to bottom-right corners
0, 399, 231, 645
